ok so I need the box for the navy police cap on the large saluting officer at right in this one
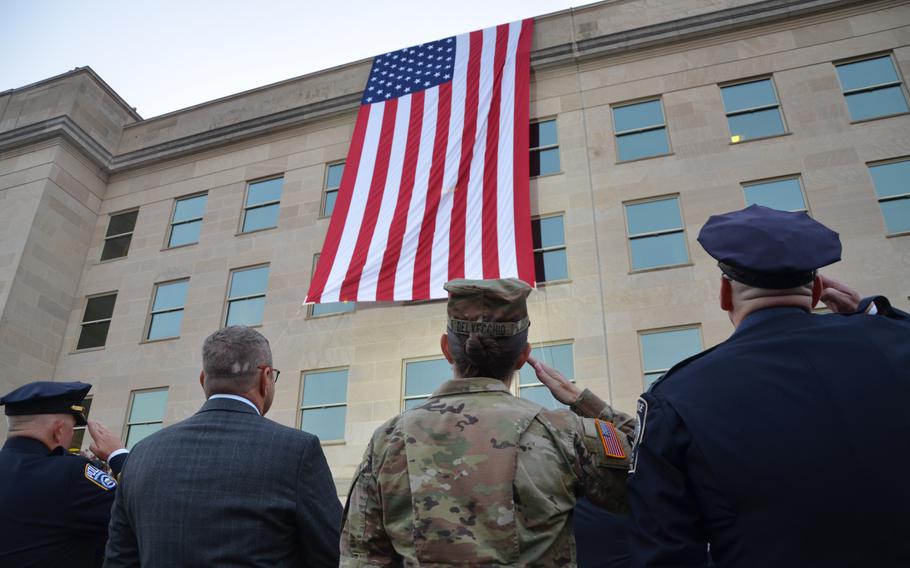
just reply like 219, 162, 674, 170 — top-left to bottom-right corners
698, 205, 841, 289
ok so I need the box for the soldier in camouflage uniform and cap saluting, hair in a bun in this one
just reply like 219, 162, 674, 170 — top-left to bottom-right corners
341, 279, 635, 566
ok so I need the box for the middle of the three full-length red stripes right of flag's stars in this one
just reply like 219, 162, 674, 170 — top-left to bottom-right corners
481, 24, 509, 278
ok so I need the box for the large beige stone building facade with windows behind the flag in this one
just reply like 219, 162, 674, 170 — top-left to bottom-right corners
0, 0, 910, 494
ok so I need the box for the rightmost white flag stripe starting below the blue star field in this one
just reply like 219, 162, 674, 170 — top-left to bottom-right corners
395, 87, 439, 301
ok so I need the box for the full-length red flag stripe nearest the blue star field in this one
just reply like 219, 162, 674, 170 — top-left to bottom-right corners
449, 31, 483, 280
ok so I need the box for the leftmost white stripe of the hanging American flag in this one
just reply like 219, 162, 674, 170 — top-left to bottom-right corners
320, 103, 385, 303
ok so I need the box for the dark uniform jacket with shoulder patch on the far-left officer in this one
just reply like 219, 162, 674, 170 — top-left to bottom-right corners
0, 437, 126, 568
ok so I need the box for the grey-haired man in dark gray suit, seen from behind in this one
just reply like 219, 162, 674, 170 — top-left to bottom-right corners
104, 326, 341, 568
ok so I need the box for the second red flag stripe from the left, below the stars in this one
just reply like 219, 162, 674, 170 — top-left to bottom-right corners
338, 98, 398, 302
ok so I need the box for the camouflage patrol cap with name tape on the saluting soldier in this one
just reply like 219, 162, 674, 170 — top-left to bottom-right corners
444, 278, 531, 337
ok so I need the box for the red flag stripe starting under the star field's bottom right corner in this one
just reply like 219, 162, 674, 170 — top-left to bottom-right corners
412, 83, 452, 298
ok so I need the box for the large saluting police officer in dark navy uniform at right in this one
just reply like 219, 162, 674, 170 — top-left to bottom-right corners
629, 205, 910, 568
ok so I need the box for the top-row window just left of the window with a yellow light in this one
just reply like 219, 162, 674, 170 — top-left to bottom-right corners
613, 99, 670, 162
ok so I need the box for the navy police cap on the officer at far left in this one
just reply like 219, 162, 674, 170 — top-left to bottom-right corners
0, 381, 92, 426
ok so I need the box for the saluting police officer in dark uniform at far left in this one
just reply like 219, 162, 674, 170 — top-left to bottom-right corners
0, 381, 127, 568
